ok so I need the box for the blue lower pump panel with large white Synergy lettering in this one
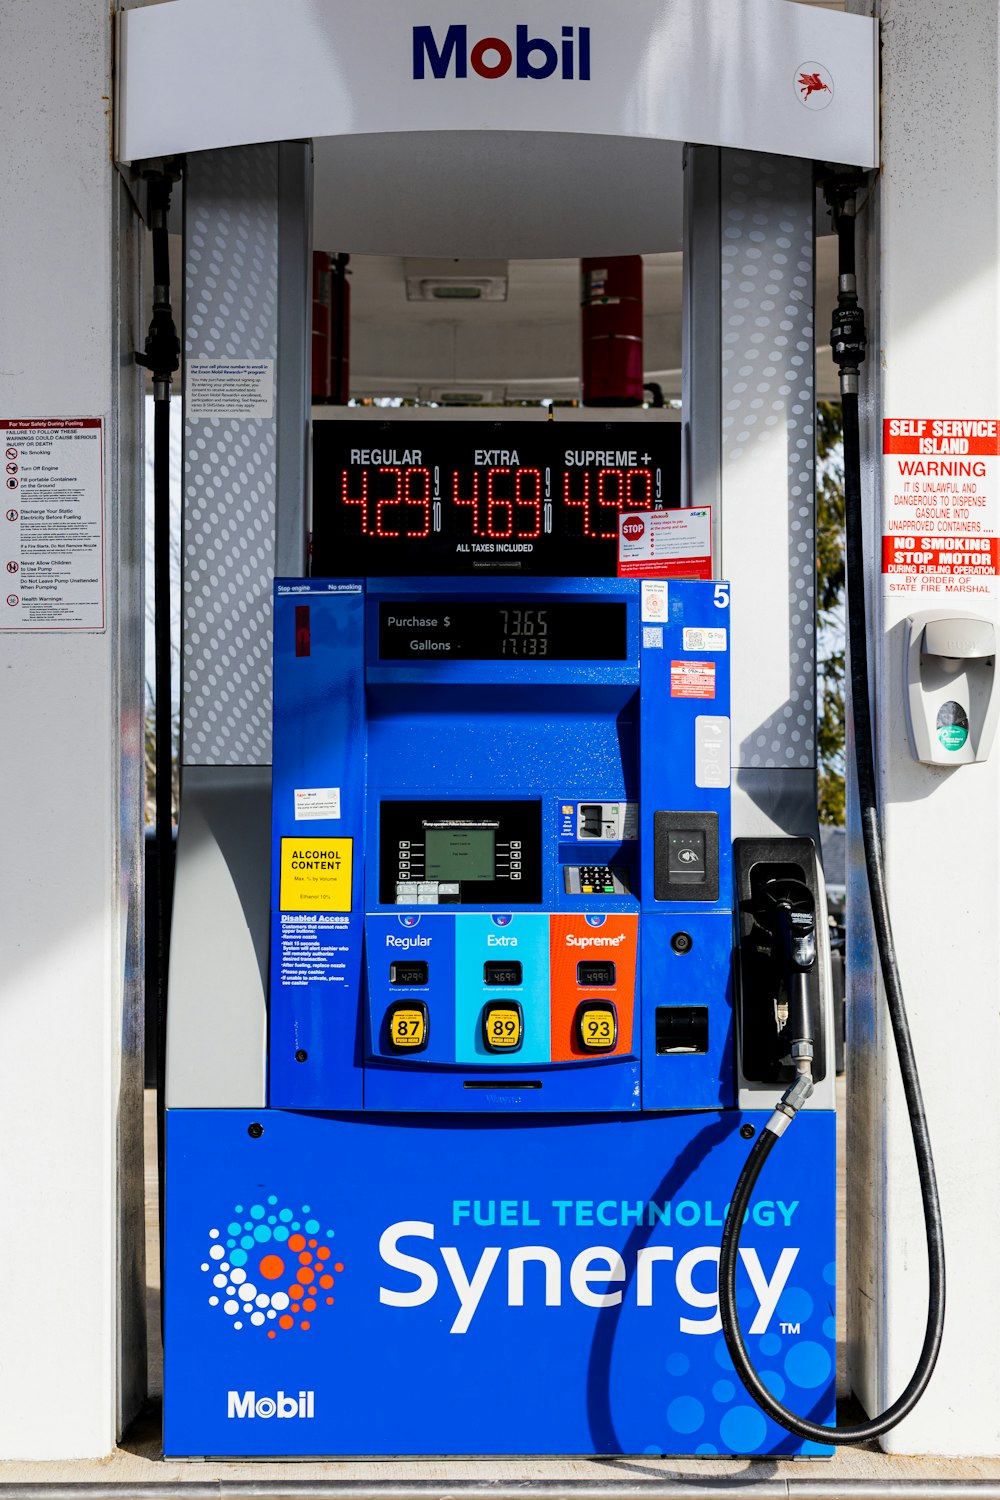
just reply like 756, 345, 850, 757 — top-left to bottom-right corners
163, 1110, 835, 1458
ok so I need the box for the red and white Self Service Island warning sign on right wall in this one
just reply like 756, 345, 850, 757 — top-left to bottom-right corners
882, 417, 1000, 599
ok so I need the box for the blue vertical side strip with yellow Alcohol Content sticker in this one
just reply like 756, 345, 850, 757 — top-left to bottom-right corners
268, 581, 364, 1110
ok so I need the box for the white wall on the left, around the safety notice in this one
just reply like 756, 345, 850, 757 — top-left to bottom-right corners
0, 0, 145, 1458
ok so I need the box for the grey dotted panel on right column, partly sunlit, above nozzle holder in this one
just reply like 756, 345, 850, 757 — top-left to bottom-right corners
720, 152, 816, 770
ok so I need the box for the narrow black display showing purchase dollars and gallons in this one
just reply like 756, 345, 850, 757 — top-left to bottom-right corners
378, 599, 627, 662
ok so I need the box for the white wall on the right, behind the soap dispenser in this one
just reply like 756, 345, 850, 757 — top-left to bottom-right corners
847, 0, 1000, 1455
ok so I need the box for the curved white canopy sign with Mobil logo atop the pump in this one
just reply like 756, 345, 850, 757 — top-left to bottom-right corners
115, 0, 879, 167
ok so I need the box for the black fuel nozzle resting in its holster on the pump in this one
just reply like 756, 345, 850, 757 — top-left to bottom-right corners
744, 878, 816, 1128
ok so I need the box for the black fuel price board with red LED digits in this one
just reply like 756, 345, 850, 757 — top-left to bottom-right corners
312, 420, 681, 578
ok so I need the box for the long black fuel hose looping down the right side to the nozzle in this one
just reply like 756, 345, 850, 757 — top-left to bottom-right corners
718, 177, 945, 1443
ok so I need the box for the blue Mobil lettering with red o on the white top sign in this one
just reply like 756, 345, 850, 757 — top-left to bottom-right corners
414, 26, 591, 83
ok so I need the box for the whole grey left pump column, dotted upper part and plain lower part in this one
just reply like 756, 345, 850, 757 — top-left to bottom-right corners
166, 143, 312, 1109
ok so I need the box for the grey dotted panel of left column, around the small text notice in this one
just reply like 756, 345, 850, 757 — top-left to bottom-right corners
181, 146, 279, 765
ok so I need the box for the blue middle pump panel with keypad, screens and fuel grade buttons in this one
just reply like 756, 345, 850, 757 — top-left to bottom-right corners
270, 578, 733, 1113
